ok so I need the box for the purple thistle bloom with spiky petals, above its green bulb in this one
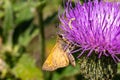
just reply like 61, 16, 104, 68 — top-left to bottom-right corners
59, 0, 120, 62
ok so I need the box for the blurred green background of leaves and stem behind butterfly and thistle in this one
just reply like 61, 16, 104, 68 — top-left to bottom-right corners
0, 0, 119, 80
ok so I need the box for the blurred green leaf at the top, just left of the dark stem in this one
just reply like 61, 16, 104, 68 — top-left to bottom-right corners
13, 1, 41, 24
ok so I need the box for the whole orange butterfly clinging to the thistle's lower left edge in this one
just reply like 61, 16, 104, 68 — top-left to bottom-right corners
42, 36, 76, 71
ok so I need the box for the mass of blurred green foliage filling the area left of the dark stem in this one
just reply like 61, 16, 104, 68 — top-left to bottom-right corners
0, 0, 45, 80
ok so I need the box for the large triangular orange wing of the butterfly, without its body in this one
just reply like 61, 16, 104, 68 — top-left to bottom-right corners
42, 42, 69, 71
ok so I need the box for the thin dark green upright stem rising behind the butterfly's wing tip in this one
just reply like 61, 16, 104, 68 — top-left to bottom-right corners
37, 0, 50, 80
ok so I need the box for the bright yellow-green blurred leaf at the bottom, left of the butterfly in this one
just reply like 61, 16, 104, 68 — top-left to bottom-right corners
12, 54, 43, 80
